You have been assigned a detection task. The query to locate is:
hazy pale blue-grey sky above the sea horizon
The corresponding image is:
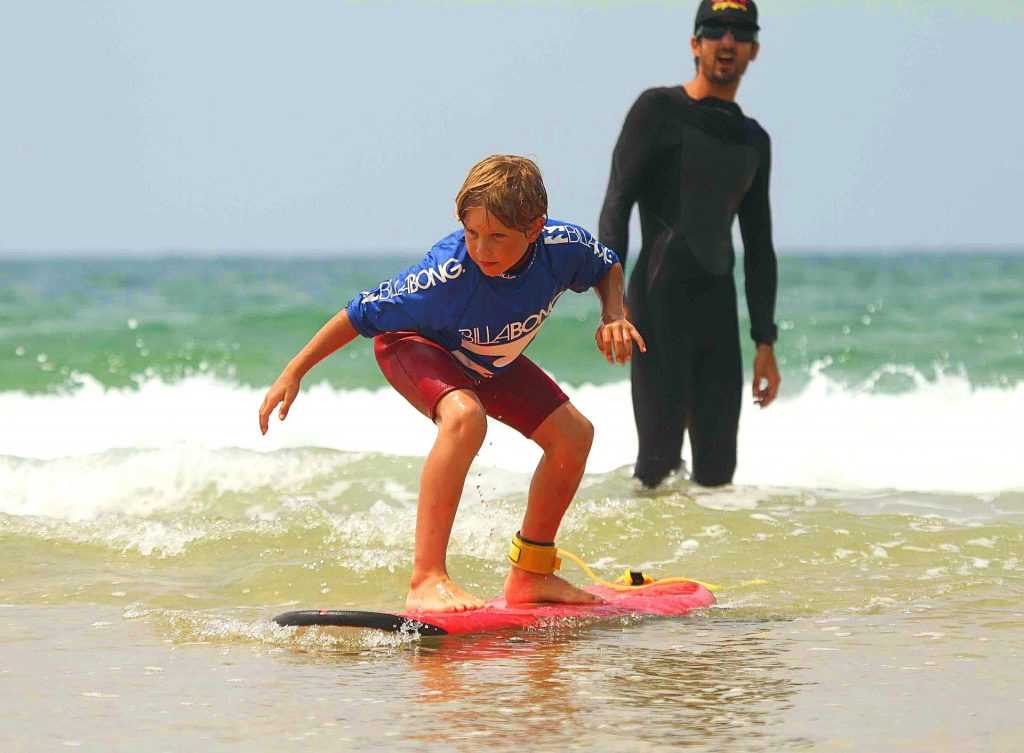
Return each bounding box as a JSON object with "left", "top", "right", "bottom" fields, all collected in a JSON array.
[{"left": 0, "top": 0, "right": 1024, "bottom": 251}]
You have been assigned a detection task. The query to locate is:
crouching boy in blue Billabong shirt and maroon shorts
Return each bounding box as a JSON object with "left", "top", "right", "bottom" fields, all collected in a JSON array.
[{"left": 259, "top": 155, "right": 645, "bottom": 612}]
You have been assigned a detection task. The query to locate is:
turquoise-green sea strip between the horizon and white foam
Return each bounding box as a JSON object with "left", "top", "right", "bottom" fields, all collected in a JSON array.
[{"left": 0, "top": 254, "right": 1024, "bottom": 392}]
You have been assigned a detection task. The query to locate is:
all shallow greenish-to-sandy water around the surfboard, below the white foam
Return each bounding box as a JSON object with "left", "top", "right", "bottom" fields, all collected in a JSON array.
[{"left": 0, "top": 473, "right": 1024, "bottom": 751}]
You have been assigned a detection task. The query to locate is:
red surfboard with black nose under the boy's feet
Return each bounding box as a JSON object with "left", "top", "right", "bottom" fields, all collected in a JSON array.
[{"left": 273, "top": 581, "right": 715, "bottom": 635}]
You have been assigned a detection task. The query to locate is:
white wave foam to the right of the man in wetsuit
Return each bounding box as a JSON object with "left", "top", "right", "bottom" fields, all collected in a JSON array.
[{"left": 736, "top": 364, "right": 1024, "bottom": 494}]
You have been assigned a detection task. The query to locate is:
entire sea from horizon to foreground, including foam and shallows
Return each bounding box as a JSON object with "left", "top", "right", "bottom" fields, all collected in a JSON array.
[{"left": 0, "top": 253, "right": 1024, "bottom": 751}]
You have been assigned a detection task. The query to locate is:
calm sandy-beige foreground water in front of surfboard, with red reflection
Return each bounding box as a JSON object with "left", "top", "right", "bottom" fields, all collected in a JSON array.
[{"left": 0, "top": 589, "right": 1024, "bottom": 751}]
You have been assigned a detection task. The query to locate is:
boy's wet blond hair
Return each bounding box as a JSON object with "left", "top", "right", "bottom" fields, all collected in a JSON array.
[{"left": 455, "top": 155, "right": 548, "bottom": 233}]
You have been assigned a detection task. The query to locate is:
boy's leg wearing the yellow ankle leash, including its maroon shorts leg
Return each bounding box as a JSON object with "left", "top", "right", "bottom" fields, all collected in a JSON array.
[{"left": 477, "top": 355, "right": 602, "bottom": 603}]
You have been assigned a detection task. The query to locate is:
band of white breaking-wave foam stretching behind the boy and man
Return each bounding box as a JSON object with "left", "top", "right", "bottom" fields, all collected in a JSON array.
[{"left": 0, "top": 374, "right": 1024, "bottom": 517}]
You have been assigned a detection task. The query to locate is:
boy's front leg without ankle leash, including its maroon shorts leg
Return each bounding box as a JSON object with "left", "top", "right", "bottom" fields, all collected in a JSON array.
[{"left": 374, "top": 333, "right": 486, "bottom": 612}]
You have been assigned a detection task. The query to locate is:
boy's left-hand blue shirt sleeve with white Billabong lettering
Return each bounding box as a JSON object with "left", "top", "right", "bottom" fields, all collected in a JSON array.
[{"left": 345, "top": 254, "right": 465, "bottom": 337}]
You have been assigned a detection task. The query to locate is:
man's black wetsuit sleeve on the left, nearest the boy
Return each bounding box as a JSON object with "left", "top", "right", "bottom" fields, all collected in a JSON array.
[{"left": 597, "top": 89, "right": 664, "bottom": 269}]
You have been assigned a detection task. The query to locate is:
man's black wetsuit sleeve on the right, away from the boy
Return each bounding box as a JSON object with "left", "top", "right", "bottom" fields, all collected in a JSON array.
[{"left": 738, "top": 128, "right": 778, "bottom": 345}]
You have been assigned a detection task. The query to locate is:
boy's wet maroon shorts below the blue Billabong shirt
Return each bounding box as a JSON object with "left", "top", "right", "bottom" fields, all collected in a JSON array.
[{"left": 374, "top": 332, "right": 568, "bottom": 437}]
